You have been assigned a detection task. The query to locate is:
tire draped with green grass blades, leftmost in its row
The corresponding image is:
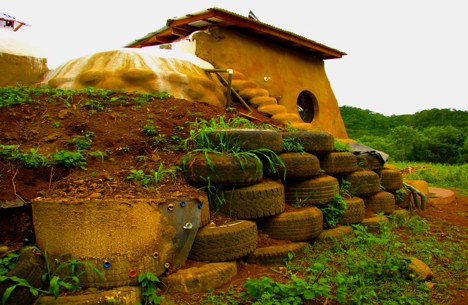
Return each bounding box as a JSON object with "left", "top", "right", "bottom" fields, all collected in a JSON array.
[{"left": 182, "top": 153, "right": 263, "bottom": 186}]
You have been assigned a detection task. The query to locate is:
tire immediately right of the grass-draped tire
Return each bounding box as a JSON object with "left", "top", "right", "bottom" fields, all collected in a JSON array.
[{"left": 264, "top": 152, "right": 320, "bottom": 182}]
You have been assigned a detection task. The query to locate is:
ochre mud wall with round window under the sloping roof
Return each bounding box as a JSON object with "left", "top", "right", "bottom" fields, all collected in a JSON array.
[{"left": 193, "top": 27, "right": 348, "bottom": 138}]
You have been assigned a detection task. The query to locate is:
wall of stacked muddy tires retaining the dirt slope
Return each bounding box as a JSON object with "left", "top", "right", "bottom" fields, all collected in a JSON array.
[{"left": 180, "top": 129, "right": 402, "bottom": 263}]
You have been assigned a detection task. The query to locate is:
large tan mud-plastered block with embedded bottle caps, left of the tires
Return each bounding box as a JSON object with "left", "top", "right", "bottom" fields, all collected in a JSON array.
[{"left": 32, "top": 198, "right": 177, "bottom": 288}]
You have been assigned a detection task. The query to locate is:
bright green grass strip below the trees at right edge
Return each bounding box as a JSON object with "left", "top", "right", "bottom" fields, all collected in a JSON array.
[{"left": 391, "top": 161, "right": 468, "bottom": 195}]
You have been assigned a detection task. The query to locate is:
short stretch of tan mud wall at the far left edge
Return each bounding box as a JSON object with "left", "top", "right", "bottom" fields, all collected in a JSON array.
[{"left": 0, "top": 53, "right": 48, "bottom": 87}]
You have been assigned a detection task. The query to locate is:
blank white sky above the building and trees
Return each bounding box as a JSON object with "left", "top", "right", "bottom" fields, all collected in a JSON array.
[{"left": 0, "top": 0, "right": 468, "bottom": 115}]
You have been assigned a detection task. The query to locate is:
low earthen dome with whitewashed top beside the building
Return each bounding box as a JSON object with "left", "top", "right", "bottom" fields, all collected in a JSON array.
[{"left": 42, "top": 49, "right": 226, "bottom": 106}]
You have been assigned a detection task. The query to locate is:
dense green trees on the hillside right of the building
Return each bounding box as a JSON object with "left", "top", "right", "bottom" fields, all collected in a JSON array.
[{"left": 340, "top": 106, "right": 468, "bottom": 164}]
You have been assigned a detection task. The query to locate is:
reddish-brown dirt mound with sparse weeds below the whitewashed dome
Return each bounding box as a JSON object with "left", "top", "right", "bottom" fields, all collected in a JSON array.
[{"left": 0, "top": 92, "right": 280, "bottom": 247}]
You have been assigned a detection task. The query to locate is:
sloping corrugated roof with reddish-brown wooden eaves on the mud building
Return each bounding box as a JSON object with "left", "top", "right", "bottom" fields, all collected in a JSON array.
[{"left": 125, "top": 8, "right": 346, "bottom": 59}]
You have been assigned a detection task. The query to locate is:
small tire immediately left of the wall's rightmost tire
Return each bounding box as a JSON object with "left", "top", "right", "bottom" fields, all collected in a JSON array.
[{"left": 343, "top": 170, "right": 380, "bottom": 197}]
